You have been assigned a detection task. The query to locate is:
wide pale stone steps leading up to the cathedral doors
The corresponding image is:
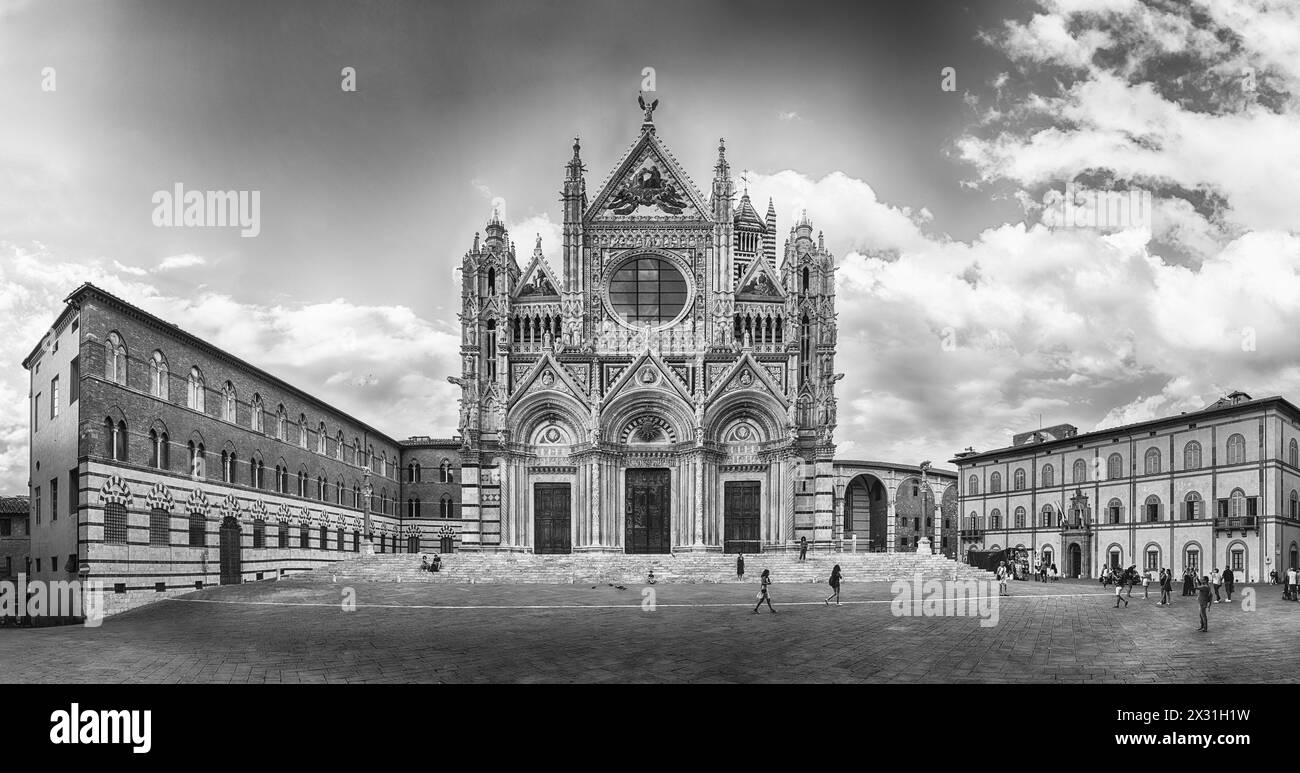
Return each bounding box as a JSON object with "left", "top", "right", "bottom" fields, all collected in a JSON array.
[{"left": 306, "top": 552, "right": 993, "bottom": 585}]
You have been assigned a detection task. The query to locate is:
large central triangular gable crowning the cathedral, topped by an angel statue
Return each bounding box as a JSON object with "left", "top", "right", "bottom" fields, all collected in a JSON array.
[{"left": 584, "top": 131, "right": 712, "bottom": 220}]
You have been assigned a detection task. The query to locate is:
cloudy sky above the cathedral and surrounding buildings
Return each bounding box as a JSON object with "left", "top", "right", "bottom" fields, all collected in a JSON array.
[{"left": 0, "top": 0, "right": 1300, "bottom": 492}]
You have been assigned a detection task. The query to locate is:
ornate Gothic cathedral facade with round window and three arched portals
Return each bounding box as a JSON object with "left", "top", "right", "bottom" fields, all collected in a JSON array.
[{"left": 451, "top": 105, "right": 839, "bottom": 553}]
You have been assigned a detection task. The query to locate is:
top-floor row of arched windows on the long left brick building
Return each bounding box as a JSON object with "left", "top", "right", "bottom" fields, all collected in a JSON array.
[{"left": 104, "top": 330, "right": 397, "bottom": 478}]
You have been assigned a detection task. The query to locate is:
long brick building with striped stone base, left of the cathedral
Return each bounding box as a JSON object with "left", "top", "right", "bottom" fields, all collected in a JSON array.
[{"left": 23, "top": 285, "right": 460, "bottom": 612}]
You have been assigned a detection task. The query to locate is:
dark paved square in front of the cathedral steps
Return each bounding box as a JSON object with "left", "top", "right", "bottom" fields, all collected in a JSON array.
[{"left": 0, "top": 576, "right": 1300, "bottom": 683}]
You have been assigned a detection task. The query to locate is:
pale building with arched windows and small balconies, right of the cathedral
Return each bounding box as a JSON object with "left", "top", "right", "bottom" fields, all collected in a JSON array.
[{"left": 953, "top": 392, "right": 1300, "bottom": 582}]
